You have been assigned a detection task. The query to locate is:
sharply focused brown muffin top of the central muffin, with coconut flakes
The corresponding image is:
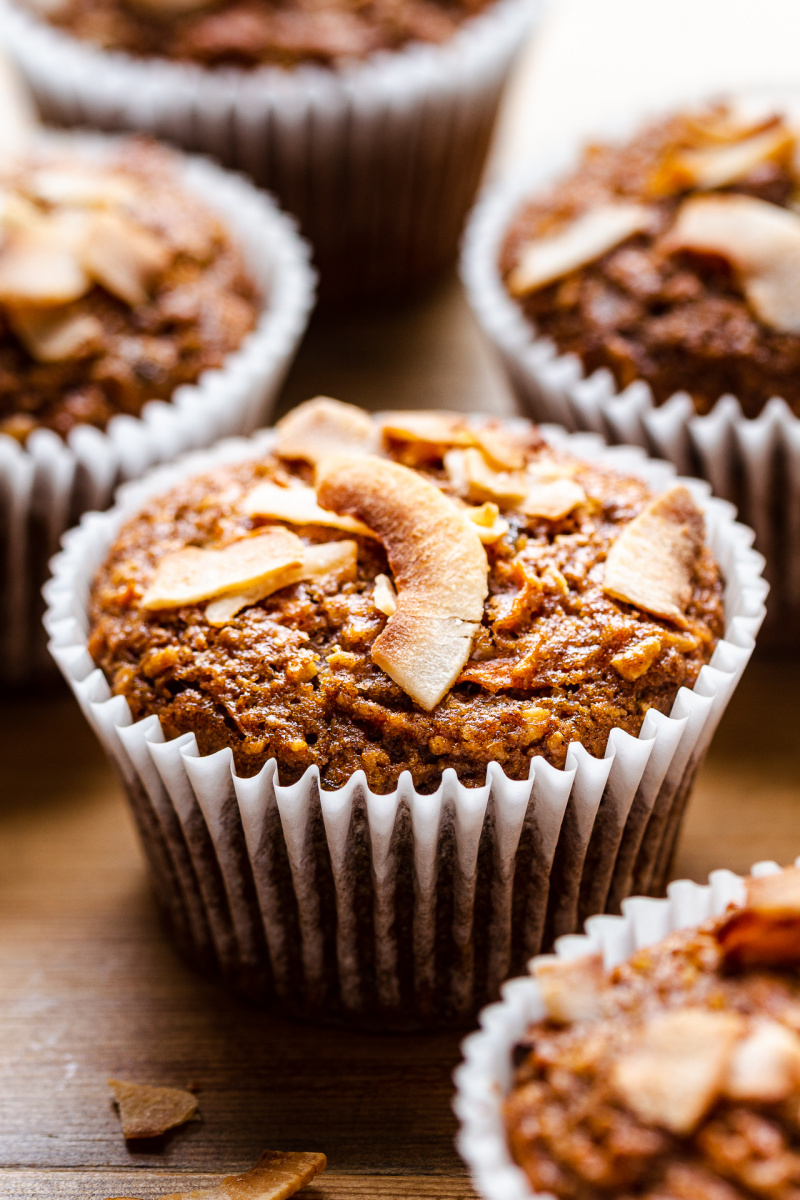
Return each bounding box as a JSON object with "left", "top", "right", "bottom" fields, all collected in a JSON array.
[{"left": 90, "top": 398, "right": 723, "bottom": 792}]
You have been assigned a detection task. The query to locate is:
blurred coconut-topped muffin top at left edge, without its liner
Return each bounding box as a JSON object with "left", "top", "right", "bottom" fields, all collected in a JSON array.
[{"left": 0, "top": 140, "right": 259, "bottom": 442}]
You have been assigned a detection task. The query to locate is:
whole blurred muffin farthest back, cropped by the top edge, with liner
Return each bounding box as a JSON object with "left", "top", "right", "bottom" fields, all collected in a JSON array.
[{"left": 0, "top": 0, "right": 540, "bottom": 301}]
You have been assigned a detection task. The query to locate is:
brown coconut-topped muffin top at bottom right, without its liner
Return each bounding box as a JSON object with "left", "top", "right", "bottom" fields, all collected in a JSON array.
[{"left": 505, "top": 869, "right": 800, "bottom": 1200}]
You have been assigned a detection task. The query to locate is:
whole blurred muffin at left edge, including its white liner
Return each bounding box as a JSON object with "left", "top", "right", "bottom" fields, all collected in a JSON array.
[{"left": 0, "top": 129, "right": 312, "bottom": 680}]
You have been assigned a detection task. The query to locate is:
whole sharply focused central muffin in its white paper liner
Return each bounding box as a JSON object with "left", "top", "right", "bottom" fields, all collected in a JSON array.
[{"left": 47, "top": 397, "right": 763, "bottom": 1026}]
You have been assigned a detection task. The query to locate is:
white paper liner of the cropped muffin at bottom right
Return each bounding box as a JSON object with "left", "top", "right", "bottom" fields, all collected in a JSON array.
[{"left": 453, "top": 858, "right": 800, "bottom": 1200}]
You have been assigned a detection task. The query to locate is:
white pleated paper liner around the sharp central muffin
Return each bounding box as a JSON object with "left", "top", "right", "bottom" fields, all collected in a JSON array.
[{"left": 46, "top": 422, "right": 766, "bottom": 1027}]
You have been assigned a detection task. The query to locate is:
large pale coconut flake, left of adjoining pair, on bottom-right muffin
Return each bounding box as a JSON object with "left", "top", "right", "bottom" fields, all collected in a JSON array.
[{"left": 612, "top": 1008, "right": 744, "bottom": 1136}]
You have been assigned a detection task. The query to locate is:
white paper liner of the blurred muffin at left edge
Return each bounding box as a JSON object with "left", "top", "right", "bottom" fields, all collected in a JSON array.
[{"left": 0, "top": 127, "right": 314, "bottom": 683}]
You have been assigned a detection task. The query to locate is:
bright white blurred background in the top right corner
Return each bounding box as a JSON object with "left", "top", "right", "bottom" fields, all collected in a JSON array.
[{"left": 493, "top": 0, "right": 800, "bottom": 172}]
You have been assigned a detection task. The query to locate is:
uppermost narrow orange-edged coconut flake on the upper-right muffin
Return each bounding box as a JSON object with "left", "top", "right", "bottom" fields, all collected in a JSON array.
[{"left": 660, "top": 126, "right": 796, "bottom": 192}]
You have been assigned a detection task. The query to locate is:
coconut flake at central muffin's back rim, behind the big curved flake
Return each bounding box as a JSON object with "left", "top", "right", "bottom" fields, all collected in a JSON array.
[{"left": 276, "top": 396, "right": 378, "bottom": 463}]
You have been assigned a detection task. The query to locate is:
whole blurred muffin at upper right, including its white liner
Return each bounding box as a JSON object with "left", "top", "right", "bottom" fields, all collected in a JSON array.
[{"left": 465, "top": 98, "right": 800, "bottom": 648}]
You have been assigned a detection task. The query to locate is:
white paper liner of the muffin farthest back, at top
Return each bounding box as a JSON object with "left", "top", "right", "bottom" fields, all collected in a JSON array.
[{"left": 0, "top": 0, "right": 543, "bottom": 298}]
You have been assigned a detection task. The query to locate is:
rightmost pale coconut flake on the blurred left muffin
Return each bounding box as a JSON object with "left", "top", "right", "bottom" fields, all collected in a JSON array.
[{"left": 83, "top": 212, "right": 173, "bottom": 308}]
